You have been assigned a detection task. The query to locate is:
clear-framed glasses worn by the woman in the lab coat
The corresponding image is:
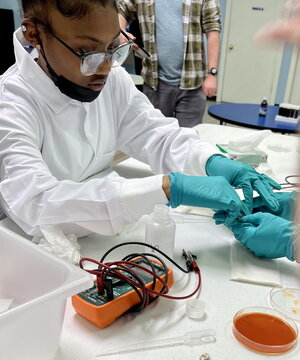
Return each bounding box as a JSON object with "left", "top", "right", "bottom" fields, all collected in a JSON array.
[{"left": 39, "top": 21, "right": 134, "bottom": 76}]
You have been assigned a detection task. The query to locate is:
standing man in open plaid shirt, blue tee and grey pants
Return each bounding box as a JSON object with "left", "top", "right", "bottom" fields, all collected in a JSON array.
[{"left": 118, "top": 0, "right": 221, "bottom": 127}]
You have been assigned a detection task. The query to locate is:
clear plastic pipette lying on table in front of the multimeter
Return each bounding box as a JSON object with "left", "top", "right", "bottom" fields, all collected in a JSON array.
[{"left": 96, "top": 329, "right": 216, "bottom": 357}]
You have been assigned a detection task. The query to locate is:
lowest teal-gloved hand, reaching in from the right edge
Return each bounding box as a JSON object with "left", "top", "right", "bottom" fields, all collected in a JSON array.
[{"left": 229, "top": 212, "right": 295, "bottom": 260}]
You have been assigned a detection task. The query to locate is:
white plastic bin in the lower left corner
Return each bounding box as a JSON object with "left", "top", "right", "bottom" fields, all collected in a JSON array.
[{"left": 0, "top": 227, "right": 93, "bottom": 360}]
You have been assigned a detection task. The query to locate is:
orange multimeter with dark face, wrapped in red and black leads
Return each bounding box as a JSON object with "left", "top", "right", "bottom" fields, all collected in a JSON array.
[{"left": 72, "top": 258, "right": 174, "bottom": 328}]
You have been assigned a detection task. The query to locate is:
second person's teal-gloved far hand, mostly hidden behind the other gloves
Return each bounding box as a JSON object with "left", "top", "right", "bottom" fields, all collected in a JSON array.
[{"left": 253, "top": 191, "right": 296, "bottom": 220}]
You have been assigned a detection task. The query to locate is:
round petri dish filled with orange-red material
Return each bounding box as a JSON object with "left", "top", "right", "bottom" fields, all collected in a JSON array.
[{"left": 232, "top": 307, "right": 298, "bottom": 354}]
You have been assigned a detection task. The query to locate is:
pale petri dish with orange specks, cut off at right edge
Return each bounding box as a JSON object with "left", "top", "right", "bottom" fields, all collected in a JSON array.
[{"left": 270, "top": 288, "right": 300, "bottom": 320}]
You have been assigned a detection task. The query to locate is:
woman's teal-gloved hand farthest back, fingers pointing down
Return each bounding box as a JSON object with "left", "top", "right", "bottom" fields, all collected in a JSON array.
[{"left": 206, "top": 155, "right": 281, "bottom": 213}]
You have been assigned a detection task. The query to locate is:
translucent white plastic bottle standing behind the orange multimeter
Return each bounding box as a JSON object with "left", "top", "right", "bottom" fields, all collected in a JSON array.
[{"left": 145, "top": 204, "right": 176, "bottom": 265}]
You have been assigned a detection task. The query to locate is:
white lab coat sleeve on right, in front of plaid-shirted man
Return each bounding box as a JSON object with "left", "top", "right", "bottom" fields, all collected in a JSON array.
[{"left": 112, "top": 69, "right": 220, "bottom": 175}]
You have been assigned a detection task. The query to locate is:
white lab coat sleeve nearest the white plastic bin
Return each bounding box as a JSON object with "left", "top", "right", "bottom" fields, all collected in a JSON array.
[{"left": 0, "top": 101, "right": 167, "bottom": 235}]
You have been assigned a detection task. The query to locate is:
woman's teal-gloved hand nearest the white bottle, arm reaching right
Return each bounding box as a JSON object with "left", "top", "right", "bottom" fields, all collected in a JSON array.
[{"left": 169, "top": 173, "right": 249, "bottom": 224}]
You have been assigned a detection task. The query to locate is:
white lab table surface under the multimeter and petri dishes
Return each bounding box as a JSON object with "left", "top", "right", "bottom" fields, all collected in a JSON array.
[{"left": 54, "top": 125, "right": 300, "bottom": 360}]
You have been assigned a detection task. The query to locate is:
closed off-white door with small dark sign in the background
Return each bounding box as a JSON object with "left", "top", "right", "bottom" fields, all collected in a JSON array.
[{"left": 217, "top": 0, "right": 285, "bottom": 104}]
